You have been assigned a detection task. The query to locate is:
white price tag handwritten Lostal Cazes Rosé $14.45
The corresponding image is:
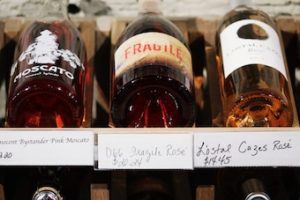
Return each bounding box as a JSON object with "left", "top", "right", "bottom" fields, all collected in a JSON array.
[{"left": 194, "top": 131, "right": 300, "bottom": 167}]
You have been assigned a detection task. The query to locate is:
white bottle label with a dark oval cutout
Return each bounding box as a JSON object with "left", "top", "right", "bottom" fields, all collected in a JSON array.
[{"left": 220, "top": 19, "right": 287, "bottom": 78}]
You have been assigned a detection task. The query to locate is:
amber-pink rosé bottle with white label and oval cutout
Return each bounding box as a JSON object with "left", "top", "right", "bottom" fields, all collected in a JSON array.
[{"left": 216, "top": 5, "right": 295, "bottom": 127}]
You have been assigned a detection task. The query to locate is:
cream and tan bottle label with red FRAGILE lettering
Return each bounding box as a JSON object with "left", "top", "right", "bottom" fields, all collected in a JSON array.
[{"left": 115, "top": 32, "right": 193, "bottom": 80}]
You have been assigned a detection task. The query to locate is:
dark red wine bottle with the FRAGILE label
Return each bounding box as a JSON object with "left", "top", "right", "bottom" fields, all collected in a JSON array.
[{"left": 111, "top": 0, "right": 195, "bottom": 127}]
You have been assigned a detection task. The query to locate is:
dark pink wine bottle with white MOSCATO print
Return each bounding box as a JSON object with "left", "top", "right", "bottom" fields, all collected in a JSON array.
[{"left": 6, "top": 0, "right": 86, "bottom": 127}]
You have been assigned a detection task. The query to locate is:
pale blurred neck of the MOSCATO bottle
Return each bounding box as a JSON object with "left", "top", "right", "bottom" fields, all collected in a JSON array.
[{"left": 39, "top": 0, "right": 69, "bottom": 21}]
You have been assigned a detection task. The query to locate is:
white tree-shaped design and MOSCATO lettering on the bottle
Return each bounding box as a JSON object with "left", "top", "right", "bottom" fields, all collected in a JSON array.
[{"left": 10, "top": 30, "right": 84, "bottom": 83}]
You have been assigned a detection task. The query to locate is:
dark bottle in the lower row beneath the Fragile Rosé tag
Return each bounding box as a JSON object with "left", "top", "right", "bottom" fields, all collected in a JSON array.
[{"left": 127, "top": 172, "right": 174, "bottom": 200}]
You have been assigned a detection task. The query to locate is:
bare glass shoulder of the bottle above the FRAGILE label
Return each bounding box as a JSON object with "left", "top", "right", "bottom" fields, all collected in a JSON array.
[{"left": 116, "top": 14, "right": 187, "bottom": 47}]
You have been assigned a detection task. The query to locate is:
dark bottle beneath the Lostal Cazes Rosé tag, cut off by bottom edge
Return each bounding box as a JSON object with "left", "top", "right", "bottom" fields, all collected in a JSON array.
[{"left": 216, "top": 168, "right": 288, "bottom": 200}]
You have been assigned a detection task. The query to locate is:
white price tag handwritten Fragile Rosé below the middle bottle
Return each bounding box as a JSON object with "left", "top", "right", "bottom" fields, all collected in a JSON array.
[{"left": 98, "top": 133, "right": 193, "bottom": 169}]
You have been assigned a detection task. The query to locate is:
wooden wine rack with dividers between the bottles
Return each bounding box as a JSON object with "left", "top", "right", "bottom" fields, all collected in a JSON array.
[{"left": 0, "top": 16, "right": 300, "bottom": 200}]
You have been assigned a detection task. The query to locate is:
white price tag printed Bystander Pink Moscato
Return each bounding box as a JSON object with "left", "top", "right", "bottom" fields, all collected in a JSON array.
[{"left": 0, "top": 131, "right": 94, "bottom": 166}]
